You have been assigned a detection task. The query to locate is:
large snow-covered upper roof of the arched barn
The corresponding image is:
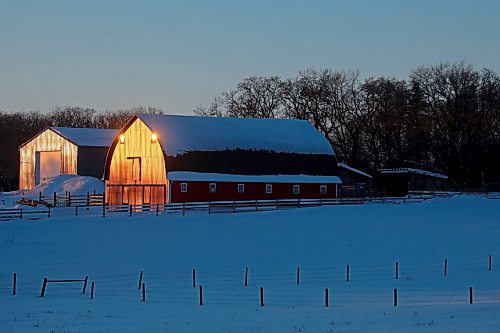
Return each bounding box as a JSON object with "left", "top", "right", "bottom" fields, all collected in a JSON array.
[{"left": 137, "top": 114, "right": 334, "bottom": 156}]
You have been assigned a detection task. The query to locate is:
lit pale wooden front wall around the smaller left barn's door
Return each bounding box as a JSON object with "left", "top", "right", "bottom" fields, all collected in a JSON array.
[{"left": 19, "top": 130, "right": 78, "bottom": 189}]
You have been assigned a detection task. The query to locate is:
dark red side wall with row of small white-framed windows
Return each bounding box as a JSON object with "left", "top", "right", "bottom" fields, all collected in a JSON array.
[{"left": 170, "top": 181, "right": 336, "bottom": 202}]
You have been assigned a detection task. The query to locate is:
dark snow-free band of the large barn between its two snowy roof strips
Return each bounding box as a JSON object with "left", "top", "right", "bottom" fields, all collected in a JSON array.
[{"left": 165, "top": 149, "right": 338, "bottom": 176}]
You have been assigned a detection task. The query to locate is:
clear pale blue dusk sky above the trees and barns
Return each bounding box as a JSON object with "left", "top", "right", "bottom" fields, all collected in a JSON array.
[{"left": 0, "top": 0, "right": 500, "bottom": 114}]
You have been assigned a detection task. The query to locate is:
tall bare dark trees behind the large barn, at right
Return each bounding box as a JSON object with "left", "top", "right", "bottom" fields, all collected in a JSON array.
[{"left": 194, "top": 62, "right": 500, "bottom": 188}]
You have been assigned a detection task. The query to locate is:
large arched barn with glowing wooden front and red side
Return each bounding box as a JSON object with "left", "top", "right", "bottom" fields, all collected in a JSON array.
[{"left": 105, "top": 114, "right": 341, "bottom": 204}]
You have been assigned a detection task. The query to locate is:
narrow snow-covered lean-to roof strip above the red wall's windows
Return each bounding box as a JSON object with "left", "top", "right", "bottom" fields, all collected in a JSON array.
[{"left": 167, "top": 171, "right": 342, "bottom": 184}]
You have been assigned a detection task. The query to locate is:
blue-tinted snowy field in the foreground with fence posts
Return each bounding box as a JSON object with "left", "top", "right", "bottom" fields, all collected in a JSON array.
[{"left": 0, "top": 196, "right": 500, "bottom": 332}]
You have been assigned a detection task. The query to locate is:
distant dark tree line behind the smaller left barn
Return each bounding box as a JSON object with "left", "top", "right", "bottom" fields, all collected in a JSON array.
[{"left": 0, "top": 106, "right": 164, "bottom": 191}]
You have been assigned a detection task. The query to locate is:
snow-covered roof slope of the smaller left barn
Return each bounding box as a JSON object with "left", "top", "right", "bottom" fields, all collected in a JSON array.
[{"left": 49, "top": 127, "right": 118, "bottom": 147}]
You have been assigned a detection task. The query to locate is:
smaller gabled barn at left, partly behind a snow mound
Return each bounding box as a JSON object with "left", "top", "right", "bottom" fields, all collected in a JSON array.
[{"left": 19, "top": 127, "right": 118, "bottom": 190}]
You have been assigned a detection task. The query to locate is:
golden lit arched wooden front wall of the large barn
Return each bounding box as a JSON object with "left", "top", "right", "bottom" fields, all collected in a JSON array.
[{"left": 106, "top": 119, "right": 168, "bottom": 205}]
